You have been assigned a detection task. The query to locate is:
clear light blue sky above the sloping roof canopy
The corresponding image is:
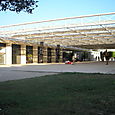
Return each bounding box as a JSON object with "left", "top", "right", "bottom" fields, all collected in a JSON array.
[{"left": 0, "top": 0, "right": 115, "bottom": 26}]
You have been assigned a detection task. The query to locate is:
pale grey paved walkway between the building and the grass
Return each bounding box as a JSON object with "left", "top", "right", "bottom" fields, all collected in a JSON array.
[{"left": 0, "top": 62, "right": 115, "bottom": 81}]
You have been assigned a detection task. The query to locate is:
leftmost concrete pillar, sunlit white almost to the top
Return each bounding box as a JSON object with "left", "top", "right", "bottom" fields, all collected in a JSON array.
[{"left": 5, "top": 43, "right": 12, "bottom": 65}]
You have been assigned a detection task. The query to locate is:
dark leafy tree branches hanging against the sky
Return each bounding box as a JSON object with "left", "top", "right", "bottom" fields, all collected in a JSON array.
[{"left": 0, "top": 0, "right": 38, "bottom": 13}]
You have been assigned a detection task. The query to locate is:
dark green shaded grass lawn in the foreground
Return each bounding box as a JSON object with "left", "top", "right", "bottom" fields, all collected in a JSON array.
[{"left": 0, "top": 73, "right": 115, "bottom": 115}]
